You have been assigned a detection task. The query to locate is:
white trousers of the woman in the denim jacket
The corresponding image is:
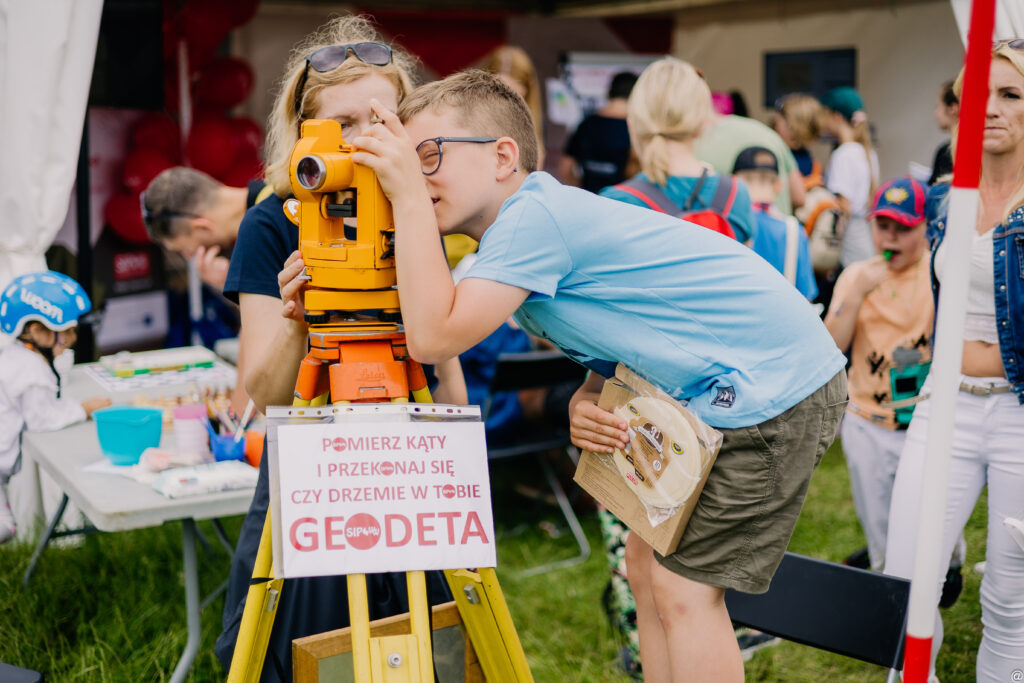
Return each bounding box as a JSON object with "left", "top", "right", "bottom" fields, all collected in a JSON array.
[{"left": 886, "top": 378, "right": 1024, "bottom": 683}]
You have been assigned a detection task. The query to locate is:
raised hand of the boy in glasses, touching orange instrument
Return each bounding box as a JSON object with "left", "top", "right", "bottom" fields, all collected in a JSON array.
[{"left": 352, "top": 99, "right": 430, "bottom": 204}]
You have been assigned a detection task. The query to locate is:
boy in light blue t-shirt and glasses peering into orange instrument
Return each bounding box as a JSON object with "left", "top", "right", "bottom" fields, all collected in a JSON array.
[{"left": 319, "top": 72, "right": 846, "bottom": 681}]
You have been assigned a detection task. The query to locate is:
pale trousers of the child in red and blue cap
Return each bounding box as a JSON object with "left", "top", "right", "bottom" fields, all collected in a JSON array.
[{"left": 840, "top": 411, "right": 906, "bottom": 571}]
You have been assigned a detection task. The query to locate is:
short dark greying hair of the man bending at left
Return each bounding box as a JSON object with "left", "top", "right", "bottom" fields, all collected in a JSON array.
[{"left": 139, "top": 166, "right": 223, "bottom": 242}]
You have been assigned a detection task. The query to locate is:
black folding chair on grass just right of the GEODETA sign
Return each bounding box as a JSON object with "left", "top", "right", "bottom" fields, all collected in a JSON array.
[{"left": 483, "top": 351, "right": 590, "bottom": 575}]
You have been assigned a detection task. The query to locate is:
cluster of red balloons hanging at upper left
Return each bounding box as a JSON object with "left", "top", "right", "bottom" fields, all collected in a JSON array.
[{"left": 103, "top": 0, "right": 263, "bottom": 243}]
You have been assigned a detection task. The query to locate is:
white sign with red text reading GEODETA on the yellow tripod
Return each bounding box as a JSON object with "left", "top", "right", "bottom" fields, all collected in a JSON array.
[{"left": 270, "top": 422, "right": 497, "bottom": 579}]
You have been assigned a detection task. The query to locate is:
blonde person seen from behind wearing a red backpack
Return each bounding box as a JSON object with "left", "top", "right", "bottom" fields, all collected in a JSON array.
[{"left": 601, "top": 57, "right": 757, "bottom": 243}]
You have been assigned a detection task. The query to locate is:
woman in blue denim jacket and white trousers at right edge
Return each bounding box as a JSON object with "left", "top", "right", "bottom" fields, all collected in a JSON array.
[{"left": 886, "top": 40, "right": 1024, "bottom": 682}]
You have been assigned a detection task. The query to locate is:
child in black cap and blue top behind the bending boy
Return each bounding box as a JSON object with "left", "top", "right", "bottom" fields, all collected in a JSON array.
[{"left": 732, "top": 146, "right": 818, "bottom": 301}]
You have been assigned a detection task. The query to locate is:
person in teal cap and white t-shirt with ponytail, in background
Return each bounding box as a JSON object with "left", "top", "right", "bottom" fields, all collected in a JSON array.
[{"left": 821, "top": 86, "right": 879, "bottom": 267}]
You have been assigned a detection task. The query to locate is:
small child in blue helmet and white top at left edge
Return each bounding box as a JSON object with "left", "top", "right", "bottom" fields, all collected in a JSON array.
[{"left": 0, "top": 271, "right": 111, "bottom": 544}]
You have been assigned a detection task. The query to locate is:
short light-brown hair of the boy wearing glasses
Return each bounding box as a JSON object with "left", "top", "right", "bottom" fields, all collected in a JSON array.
[{"left": 398, "top": 69, "right": 538, "bottom": 173}]
